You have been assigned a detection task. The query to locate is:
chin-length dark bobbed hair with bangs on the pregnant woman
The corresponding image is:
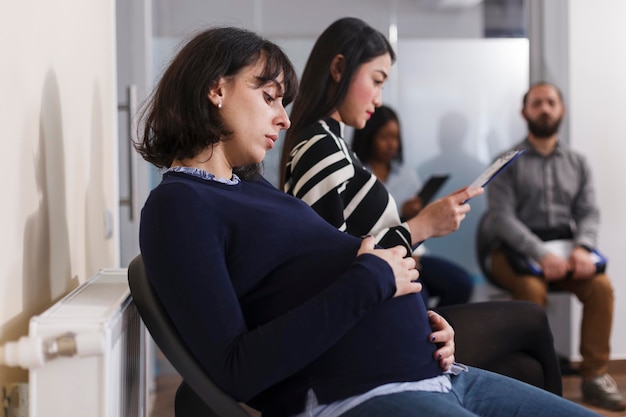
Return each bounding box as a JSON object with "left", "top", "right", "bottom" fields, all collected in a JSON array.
[{"left": 135, "top": 27, "right": 298, "bottom": 178}]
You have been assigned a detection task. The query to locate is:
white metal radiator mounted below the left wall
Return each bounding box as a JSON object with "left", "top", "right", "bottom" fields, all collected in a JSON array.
[{"left": 29, "top": 269, "right": 148, "bottom": 417}]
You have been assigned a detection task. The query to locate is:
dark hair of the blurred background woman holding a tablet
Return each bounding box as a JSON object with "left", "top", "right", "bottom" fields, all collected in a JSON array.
[{"left": 352, "top": 106, "right": 403, "bottom": 164}]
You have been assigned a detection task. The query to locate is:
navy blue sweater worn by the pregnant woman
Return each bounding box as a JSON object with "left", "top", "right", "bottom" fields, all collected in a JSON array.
[{"left": 140, "top": 172, "right": 442, "bottom": 416}]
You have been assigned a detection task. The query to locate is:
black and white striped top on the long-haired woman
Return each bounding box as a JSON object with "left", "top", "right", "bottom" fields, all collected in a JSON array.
[{"left": 284, "top": 118, "right": 411, "bottom": 253}]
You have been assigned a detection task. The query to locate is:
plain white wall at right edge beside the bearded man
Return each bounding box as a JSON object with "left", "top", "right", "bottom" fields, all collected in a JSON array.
[{"left": 568, "top": 0, "right": 626, "bottom": 359}]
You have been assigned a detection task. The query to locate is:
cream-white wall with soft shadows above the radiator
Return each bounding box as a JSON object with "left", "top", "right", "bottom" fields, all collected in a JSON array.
[{"left": 0, "top": 0, "right": 118, "bottom": 385}]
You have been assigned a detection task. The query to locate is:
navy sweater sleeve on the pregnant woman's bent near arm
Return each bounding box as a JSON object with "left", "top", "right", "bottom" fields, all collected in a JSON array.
[{"left": 140, "top": 184, "right": 395, "bottom": 401}]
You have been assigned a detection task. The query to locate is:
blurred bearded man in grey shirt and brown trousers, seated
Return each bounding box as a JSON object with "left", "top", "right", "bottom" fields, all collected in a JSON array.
[{"left": 479, "top": 82, "right": 626, "bottom": 411}]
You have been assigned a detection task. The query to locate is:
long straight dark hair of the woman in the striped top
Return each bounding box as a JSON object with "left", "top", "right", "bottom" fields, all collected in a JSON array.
[{"left": 280, "top": 17, "right": 396, "bottom": 188}]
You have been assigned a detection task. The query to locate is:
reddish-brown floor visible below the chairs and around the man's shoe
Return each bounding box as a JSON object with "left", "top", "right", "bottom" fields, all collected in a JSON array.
[{"left": 150, "top": 354, "right": 626, "bottom": 417}]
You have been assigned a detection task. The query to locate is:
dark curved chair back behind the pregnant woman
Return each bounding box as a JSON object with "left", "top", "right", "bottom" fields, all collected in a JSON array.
[{"left": 128, "top": 255, "right": 250, "bottom": 417}]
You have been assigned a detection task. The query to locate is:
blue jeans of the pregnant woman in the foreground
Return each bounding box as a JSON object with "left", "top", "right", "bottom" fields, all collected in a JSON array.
[{"left": 334, "top": 368, "right": 599, "bottom": 417}]
